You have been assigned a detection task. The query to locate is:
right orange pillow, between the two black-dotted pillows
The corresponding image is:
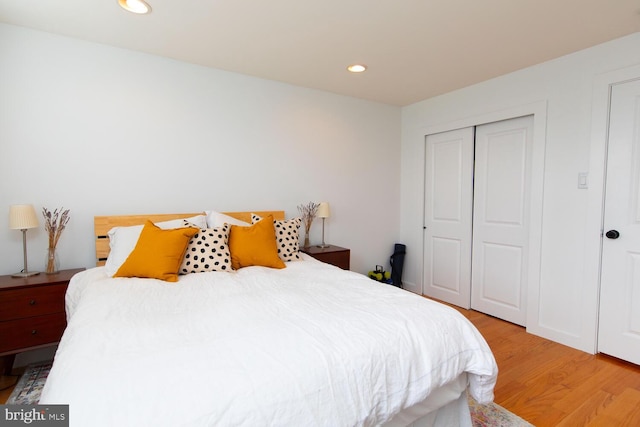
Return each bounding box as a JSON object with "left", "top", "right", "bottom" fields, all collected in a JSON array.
[{"left": 229, "top": 215, "right": 285, "bottom": 270}]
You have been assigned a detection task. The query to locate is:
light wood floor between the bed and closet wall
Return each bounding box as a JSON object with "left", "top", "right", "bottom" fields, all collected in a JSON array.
[{"left": 454, "top": 307, "right": 640, "bottom": 427}]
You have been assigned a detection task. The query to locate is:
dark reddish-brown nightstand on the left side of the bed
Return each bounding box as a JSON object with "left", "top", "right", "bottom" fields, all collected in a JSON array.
[{"left": 0, "top": 268, "right": 84, "bottom": 373}]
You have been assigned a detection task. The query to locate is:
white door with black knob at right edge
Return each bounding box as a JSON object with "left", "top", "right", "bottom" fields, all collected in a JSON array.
[{"left": 598, "top": 80, "right": 640, "bottom": 364}]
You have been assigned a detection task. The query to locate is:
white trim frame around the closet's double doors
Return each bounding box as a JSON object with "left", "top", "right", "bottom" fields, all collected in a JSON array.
[{"left": 421, "top": 100, "right": 547, "bottom": 335}]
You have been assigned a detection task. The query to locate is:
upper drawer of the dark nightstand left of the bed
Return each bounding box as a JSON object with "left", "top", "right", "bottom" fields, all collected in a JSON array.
[{"left": 0, "top": 283, "right": 67, "bottom": 322}]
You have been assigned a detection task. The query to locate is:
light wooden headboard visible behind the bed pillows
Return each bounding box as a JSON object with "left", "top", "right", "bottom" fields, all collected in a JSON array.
[{"left": 93, "top": 211, "right": 284, "bottom": 266}]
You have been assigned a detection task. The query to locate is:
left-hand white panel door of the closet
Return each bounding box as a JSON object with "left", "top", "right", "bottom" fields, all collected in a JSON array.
[{"left": 423, "top": 127, "right": 474, "bottom": 308}]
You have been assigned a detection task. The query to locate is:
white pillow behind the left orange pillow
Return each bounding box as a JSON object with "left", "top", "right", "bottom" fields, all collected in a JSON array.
[{"left": 104, "top": 215, "right": 207, "bottom": 277}]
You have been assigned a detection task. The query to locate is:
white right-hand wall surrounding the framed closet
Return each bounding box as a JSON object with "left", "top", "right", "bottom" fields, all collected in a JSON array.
[{"left": 401, "top": 33, "right": 640, "bottom": 352}]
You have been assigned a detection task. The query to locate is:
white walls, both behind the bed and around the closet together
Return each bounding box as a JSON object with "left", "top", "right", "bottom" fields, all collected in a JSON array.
[{"left": 6, "top": 24, "right": 640, "bottom": 360}]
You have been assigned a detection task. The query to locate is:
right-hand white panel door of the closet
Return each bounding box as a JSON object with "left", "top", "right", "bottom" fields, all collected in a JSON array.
[{"left": 471, "top": 116, "right": 533, "bottom": 326}]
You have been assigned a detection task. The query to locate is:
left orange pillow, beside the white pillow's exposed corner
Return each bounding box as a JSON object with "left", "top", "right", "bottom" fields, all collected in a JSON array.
[{"left": 113, "top": 221, "right": 199, "bottom": 282}]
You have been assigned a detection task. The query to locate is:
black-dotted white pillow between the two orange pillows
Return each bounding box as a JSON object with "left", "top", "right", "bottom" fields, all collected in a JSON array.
[{"left": 179, "top": 221, "right": 233, "bottom": 274}]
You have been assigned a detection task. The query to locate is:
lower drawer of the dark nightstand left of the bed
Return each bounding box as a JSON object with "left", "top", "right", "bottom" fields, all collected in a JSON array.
[{"left": 0, "top": 312, "right": 67, "bottom": 353}]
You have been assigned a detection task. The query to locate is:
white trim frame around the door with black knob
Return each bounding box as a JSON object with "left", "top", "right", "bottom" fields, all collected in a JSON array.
[{"left": 581, "top": 65, "right": 640, "bottom": 354}]
